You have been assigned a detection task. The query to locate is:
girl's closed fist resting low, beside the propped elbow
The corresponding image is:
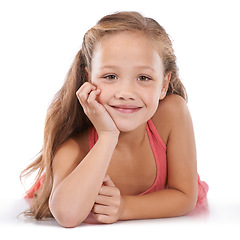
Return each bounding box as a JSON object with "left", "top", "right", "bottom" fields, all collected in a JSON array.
[{"left": 92, "top": 175, "right": 124, "bottom": 223}]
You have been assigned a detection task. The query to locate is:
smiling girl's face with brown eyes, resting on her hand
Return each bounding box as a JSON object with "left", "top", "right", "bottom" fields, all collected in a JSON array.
[{"left": 90, "top": 32, "right": 168, "bottom": 132}]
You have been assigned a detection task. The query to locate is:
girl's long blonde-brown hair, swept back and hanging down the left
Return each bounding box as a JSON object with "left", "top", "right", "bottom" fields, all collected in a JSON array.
[{"left": 21, "top": 12, "right": 187, "bottom": 220}]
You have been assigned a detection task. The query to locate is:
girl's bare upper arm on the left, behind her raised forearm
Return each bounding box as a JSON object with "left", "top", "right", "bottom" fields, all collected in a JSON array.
[{"left": 52, "top": 131, "right": 89, "bottom": 188}]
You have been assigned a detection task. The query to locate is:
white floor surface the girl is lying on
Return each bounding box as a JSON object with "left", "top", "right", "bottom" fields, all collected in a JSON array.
[{"left": 0, "top": 198, "right": 240, "bottom": 240}]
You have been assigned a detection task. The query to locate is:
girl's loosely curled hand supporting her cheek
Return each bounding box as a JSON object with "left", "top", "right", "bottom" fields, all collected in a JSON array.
[{"left": 76, "top": 82, "right": 119, "bottom": 137}]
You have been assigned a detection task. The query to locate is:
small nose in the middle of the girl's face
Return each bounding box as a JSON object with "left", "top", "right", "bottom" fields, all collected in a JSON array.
[{"left": 115, "top": 81, "right": 136, "bottom": 101}]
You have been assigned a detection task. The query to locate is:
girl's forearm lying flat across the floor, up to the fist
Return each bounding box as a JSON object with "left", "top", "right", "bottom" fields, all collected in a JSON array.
[{"left": 120, "top": 189, "right": 196, "bottom": 220}]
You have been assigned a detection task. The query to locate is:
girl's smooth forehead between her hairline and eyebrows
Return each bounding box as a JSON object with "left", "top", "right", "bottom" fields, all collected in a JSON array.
[{"left": 92, "top": 31, "right": 162, "bottom": 71}]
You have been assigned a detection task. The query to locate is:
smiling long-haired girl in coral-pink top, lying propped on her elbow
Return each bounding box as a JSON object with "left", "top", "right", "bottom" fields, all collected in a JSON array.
[{"left": 20, "top": 12, "right": 208, "bottom": 227}]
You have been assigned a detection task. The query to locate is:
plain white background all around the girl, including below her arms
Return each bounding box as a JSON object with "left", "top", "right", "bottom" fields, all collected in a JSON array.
[{"left": 0, "top": 0, "right": 240, "bottom": 239}]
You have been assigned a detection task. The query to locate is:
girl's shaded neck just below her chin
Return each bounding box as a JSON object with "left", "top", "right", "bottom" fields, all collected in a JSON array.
[{"left": 116, "top": 123, "right": 147, "bottom": 150}]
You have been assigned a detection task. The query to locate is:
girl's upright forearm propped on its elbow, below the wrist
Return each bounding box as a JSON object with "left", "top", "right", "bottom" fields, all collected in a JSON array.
[{"left": 49, "top": 136, "right": 117, "bottom": 226}]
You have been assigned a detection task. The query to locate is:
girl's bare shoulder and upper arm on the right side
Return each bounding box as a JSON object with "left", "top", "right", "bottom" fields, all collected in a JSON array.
[{"left": 154, "top": 95, "right": 197, "bottom": 204}]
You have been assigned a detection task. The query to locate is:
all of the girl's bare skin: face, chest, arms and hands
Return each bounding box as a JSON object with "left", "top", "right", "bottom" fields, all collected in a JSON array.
[{"left": 49, "top": 32, "right": 197, "bottom": 227}]
